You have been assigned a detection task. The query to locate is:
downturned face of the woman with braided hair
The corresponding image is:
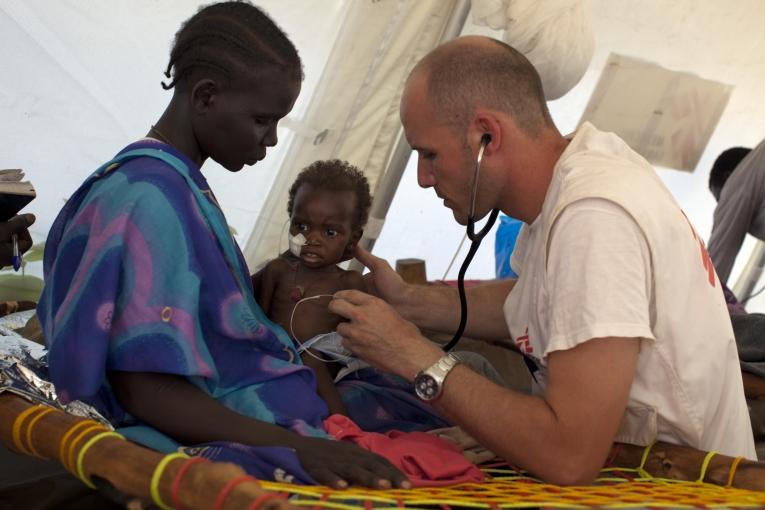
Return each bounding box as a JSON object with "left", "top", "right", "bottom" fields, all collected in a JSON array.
[{"left": 192, "top": 67, "right": 301, "bottom": 172}]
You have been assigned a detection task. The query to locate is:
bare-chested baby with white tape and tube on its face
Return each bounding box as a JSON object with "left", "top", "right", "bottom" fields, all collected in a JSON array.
[{"left": 252, "top": 160, "right": 372, "bottom": 414}]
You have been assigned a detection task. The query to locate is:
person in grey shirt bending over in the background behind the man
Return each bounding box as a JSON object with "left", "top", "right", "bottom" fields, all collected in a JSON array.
[{"left": 707, "top": 140, "right": 765, "bottom": 283}]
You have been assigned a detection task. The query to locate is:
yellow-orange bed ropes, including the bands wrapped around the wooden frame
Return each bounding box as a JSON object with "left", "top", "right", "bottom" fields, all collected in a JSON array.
[{"left": 5, "top": 406, "right": 765, "bottom": 510}]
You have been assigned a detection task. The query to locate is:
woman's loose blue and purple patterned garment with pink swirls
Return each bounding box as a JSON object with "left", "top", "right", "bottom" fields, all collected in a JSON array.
[{"left": 38, "top": 139, "right": 447, "bottom": 479}]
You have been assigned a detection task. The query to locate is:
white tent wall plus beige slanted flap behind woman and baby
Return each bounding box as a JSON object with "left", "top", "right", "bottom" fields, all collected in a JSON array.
[{"left": 0, "top": 0, "right": 592, "bottom": 282}]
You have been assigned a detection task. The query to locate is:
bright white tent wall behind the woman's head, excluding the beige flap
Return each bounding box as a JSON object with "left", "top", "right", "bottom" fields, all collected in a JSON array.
[{"left": 0, "top": 0, "right": 352, "bottom": 275}]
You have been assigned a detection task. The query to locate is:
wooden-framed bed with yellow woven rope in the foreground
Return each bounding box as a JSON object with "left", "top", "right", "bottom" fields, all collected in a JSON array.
[{"left": 0, "top": 393, "right": 765, "bottom": 510}]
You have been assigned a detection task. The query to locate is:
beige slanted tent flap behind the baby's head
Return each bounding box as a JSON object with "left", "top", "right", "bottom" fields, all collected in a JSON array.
[{"left": 244, "top": 0, "right": 455, "bottom": 268}]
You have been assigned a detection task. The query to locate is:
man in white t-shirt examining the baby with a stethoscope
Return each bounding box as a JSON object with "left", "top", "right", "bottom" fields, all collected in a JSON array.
[{"left": 330, "top": 37, "right": 756, "bottom": 484}]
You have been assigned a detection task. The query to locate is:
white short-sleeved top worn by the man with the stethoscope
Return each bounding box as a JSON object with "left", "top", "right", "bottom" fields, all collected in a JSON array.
[{"left": 505, "top": 124, "right": 756, "bottom": 459}]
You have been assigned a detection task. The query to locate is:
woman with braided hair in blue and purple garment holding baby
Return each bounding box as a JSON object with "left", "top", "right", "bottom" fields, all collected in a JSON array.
[{"left": 38, "top": 2, "right": 408, "bottom": 488}]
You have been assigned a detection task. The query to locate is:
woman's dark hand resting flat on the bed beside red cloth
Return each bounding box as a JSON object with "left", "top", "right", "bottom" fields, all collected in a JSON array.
[{"left": 295, "top": 437, "right": 411, "bottom": 489}]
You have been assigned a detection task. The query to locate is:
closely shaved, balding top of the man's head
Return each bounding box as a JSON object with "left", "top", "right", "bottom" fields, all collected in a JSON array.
[{"left": 407, "top": 36, "right": 552, "bottom": 136}]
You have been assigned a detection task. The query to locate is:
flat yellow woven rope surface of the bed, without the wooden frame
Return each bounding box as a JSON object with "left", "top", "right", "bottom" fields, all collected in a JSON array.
[{"left": 252, "top": 464, "right": 765, "bottom": 510}]
